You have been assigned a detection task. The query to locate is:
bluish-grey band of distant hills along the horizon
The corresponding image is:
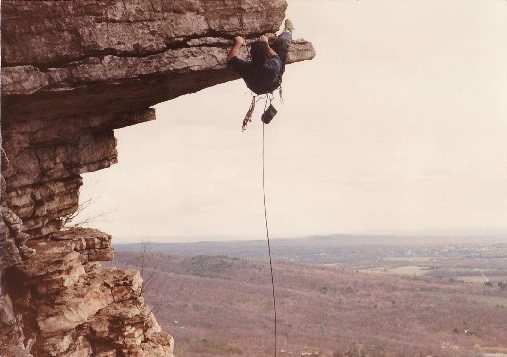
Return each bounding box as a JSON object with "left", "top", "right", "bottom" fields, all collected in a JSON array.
[{"left": 114, "top": 234, "right": 507, "bottom": 263}]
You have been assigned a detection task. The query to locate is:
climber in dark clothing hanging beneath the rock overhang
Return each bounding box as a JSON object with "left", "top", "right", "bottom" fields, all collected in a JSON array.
[{"left": 227, "top": 19, "right": 294, "bottom": 95}]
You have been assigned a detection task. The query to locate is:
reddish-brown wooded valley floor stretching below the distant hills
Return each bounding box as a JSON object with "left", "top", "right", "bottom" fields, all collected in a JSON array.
[{"left": 114, "top": 235, "right": 507, "bottom": 356}]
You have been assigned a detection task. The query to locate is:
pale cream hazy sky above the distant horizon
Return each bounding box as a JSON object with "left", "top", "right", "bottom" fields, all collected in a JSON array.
[{"left": 81, "top": 0, "right": 507, "bottom": 242}]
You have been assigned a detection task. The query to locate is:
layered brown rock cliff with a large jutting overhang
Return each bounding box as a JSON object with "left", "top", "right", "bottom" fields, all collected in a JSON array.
[{"left": 0, "top": 0, "right": 315, "bottom": 356}]
